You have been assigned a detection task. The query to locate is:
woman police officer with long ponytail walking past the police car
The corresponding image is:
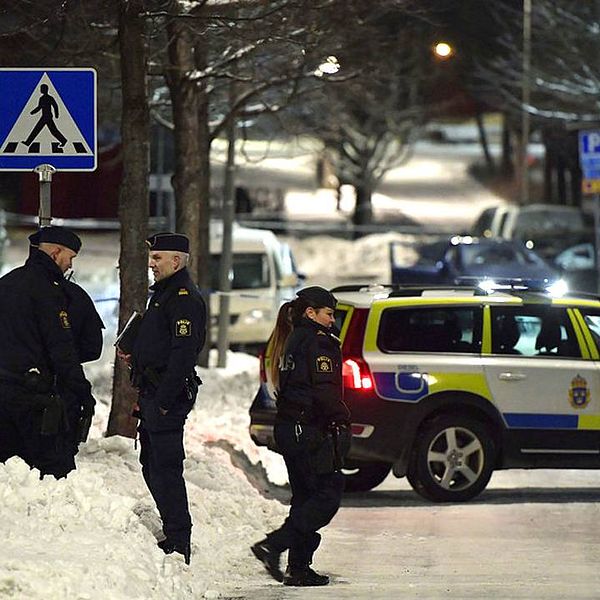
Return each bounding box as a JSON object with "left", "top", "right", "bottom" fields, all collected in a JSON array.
[{"left": 251, "top": 286, "right": 350, "bottom": 586}]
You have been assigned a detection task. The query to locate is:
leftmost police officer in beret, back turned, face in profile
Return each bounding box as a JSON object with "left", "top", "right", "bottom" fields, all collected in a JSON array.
[{"left": 0, "top": 226, "right": 95, "bottom": 479}]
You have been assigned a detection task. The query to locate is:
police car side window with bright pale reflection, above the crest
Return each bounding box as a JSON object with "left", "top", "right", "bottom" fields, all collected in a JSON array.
[{"left": 491, "top": 306, "right": 581, "bottom": 358}]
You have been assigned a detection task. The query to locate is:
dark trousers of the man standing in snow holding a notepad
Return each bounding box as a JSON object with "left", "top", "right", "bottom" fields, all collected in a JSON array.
[{"left": 138, "top": 396, "right": 193, "bottom": 544}]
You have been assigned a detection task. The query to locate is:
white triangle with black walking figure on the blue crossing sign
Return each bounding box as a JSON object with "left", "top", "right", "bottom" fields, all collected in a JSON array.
[{"left": 0, "top": 73, "right": 93, "bottom": 156}]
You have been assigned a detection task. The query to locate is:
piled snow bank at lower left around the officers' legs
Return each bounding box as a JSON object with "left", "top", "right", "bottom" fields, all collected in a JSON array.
[{"left": 0, "top": 353, "right": 286, "bottom": 600}]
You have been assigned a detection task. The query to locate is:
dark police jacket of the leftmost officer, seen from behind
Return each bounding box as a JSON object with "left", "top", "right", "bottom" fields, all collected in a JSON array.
[{"left": 0, "top": 249, "right": 94, "bottom": 403}]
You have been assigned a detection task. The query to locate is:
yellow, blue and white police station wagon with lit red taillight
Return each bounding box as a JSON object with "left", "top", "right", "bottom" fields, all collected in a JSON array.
[{"left": 250, "top": 282, "right": 600, "bottom": 502}]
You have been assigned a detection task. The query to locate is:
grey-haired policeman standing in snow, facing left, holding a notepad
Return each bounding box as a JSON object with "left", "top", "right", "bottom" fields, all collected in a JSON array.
[{"left": 121, "top": 232, "right": 206, "bottom": 564}]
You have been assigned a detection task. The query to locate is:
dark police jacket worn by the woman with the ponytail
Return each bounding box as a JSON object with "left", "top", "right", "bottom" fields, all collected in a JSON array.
[{"left": 277, "top": 317, "right": 350, "bottom": 427}]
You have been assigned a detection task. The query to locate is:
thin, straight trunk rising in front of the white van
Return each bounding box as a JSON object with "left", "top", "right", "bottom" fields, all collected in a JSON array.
[{"left": 195, "top": 28, "right": 211, "bottom": 367}]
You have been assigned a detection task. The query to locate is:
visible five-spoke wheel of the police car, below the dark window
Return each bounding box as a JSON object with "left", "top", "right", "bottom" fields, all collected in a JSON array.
[{"left": 408, "top": 415, "right": 494, "bottom": 502}]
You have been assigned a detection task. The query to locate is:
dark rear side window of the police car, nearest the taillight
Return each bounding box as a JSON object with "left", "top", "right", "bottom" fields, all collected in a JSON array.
[{"left": 377, "top": 306, "right": 481, "bottom": 353}]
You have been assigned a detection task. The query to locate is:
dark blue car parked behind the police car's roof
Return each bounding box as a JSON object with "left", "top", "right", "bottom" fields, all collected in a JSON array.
[{"left": 390, "top": 236, "right": 561, "bottom": 286}]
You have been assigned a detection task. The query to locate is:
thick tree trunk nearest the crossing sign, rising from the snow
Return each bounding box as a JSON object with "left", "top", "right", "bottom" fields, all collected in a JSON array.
[{"left": 106, "top": 0, "right": 150, "bottom": 437}]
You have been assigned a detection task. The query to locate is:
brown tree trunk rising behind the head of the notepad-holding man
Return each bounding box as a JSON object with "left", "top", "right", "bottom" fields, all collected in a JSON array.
[{"left": 166, "top": 7, "right": 206, "bottom": 274}]
